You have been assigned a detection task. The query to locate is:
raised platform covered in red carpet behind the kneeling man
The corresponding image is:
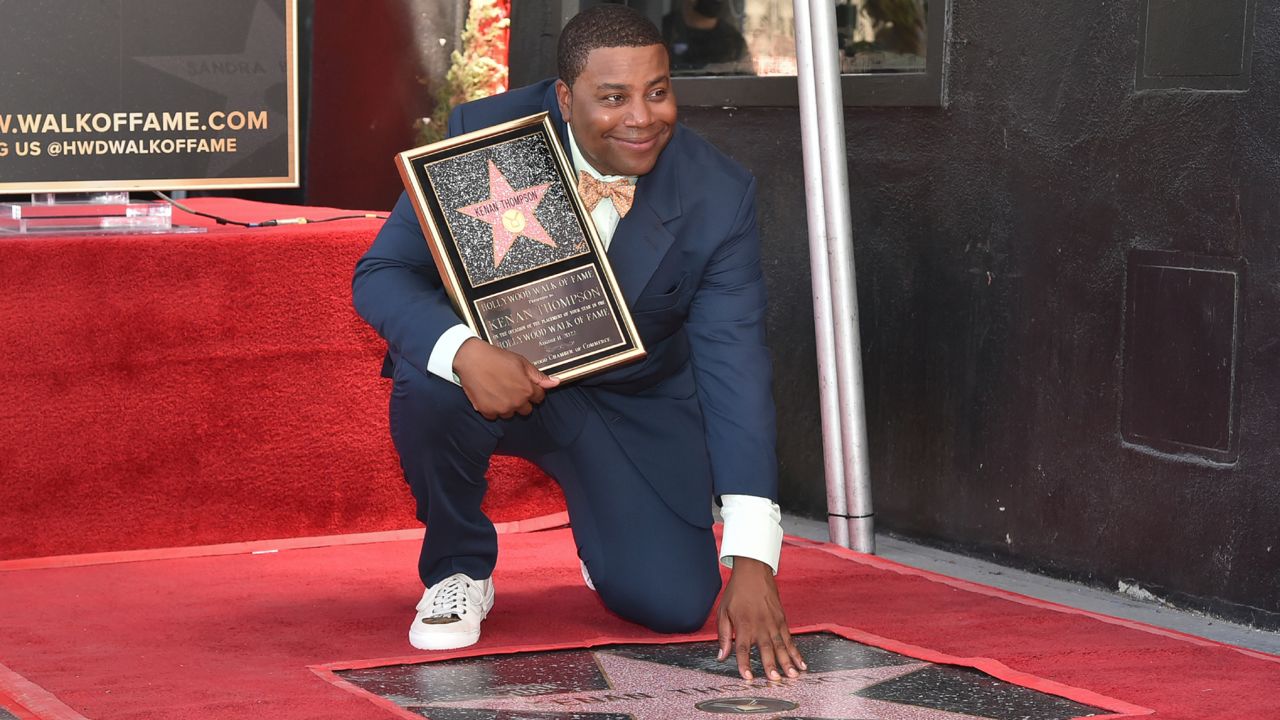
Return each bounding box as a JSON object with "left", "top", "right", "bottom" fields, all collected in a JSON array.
[{"left": 0, "top": 199, "right": 563, "bottom": 560}]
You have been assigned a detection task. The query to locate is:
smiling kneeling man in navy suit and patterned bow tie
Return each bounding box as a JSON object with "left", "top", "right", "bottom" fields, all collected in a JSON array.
[{"left": 353, "top": 5, "right": 804, "bottom": 679}]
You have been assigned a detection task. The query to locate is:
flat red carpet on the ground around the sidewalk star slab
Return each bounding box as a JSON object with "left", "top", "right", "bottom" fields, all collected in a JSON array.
[{"left": 0, "top": 530, "right": 1280, "bottom": 720}]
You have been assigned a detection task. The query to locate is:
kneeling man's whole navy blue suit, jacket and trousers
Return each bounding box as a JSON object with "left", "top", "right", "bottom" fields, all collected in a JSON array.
[{"left": 353, "top": 81, "right": 777, "bottom": 630}]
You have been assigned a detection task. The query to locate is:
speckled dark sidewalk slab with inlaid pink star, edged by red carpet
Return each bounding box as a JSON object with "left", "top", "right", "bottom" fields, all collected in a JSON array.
[{"left": 339, "top": 633, "right": 1123, "bottom": 720}]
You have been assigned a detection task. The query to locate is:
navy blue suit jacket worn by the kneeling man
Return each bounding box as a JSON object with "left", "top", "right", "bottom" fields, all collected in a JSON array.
[{"left": 352, "top": 79, "right": 777, "bottom": 527}]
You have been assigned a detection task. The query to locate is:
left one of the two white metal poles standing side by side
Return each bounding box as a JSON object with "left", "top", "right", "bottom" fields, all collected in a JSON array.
[{"left": 794, "top": 0, "right": 849, "bottom": 547}]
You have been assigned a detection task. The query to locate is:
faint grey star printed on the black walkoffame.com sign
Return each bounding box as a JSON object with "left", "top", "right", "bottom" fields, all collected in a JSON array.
[{"left": 134, "top": 0, "right": 288, "bottom": 177}]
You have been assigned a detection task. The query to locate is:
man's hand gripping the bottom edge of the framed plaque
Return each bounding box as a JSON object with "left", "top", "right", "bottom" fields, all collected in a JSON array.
[{"left": 453, "top": 337, "right": 559, "bottom": 420}]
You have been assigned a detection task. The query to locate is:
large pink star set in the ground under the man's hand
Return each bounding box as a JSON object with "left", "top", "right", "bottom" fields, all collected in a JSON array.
[{"left": 420, "top": 652, "right": 998, "bottom": 720}]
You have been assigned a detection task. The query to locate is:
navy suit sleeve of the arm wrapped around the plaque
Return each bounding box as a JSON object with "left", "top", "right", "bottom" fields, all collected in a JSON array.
[{"left": 351, "top": 106, "right": 465, "bottom": 374}]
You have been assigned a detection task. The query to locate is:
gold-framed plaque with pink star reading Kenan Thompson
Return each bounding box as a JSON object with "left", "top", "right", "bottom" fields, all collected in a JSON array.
[{"left": 396, "top": 113, "right": 645, "bottom": 380}]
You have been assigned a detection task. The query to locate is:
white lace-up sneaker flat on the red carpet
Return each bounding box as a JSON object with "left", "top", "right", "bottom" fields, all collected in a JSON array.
[{"left": 408, "top": 573, "right": 493, "bottom": 650}]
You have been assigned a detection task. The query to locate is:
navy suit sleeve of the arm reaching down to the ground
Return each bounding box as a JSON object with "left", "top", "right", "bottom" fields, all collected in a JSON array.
[{"left": 685, "top": 178, "right": 778, "bottom": 501}]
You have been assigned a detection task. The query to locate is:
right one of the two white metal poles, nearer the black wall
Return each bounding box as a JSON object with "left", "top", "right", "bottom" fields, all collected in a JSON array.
[{"left": 809, "top": 0, "right": 876, "bottom": 552}]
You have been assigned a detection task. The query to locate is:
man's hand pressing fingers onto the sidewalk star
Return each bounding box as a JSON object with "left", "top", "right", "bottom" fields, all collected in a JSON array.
[{"left": 717, "top": 557, "right": 809, "bottom": 680}]
